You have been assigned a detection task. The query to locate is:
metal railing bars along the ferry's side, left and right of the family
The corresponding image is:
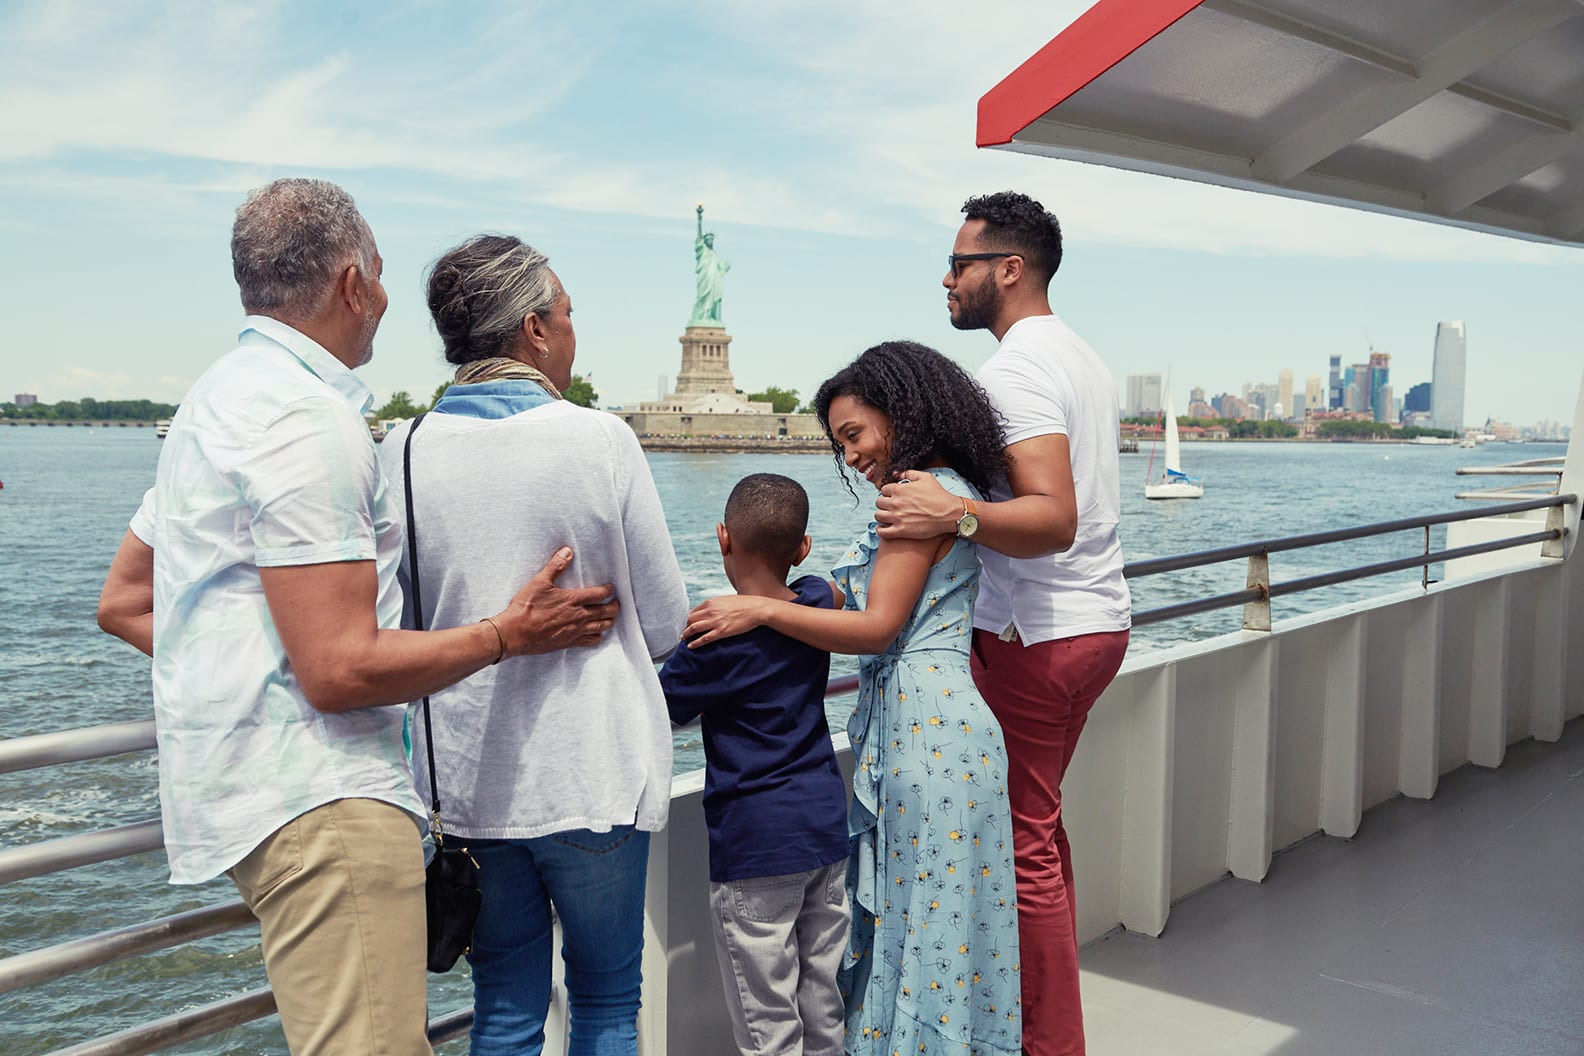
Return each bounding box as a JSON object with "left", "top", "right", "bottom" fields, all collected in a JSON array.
[{"left": 0, "top": 494, "right": 1578, "bottom": 1056}]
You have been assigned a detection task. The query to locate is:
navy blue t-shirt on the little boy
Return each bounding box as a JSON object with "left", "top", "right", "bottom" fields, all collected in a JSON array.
[{"left": 661, "top": 576, "right": 847, "bottom": 883}]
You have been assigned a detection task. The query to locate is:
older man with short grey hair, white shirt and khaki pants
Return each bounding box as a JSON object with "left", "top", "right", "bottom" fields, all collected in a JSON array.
[{"left": 100, "top": 179, "right": 616, "bottom": 1056}]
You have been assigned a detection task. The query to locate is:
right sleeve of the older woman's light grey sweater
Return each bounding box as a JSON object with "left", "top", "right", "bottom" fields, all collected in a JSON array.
[{"left": 608, "top": 420, "right": 687, "bottom": 659}]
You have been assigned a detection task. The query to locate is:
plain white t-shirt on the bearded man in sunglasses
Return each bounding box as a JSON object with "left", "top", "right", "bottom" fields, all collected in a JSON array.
[{"left": 974, "top": 315, "right": 1133, "bottom": 644}]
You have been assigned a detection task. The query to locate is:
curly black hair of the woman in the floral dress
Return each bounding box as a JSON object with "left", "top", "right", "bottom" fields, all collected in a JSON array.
[{"left": 814, "top": 340, "right": 1006, "bottom": 497}]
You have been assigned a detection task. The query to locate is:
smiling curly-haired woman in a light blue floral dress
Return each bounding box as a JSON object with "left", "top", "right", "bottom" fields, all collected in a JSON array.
[{"left": 684, "top": 342, "right": 1022, "bottom": 1056}]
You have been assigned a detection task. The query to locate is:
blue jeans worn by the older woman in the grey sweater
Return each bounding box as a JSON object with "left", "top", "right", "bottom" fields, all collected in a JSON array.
[{"left": 467, "top": 825, "right": 649, "bottom": 1056}]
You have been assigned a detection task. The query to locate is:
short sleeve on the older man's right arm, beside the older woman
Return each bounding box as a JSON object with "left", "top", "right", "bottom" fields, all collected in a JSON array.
[{"left": 233, "top": 396, "right": 380, "bottom": 568}]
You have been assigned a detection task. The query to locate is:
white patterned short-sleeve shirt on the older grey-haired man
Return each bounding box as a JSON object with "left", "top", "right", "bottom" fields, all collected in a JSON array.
[{"left": 131, "top": 315, "right": 421, "bottom": 883}]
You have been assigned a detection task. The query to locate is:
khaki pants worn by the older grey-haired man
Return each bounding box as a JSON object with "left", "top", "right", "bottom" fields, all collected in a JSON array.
[{"left": 227, "top": 800, "right": 432, "bottom": 1056}]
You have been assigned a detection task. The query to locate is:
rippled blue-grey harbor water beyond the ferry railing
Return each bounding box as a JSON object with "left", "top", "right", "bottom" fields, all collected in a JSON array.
[{"left": 0, "top": 427, "right": 1563, "bottom": 1056}]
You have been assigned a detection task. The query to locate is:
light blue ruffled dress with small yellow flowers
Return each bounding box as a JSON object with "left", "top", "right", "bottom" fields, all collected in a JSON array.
[{"left": 832, "top": 469, "right": 1022, "bottom": 1056}]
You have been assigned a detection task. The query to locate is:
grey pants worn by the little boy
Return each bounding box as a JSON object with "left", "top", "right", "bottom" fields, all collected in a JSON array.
[{"left": 710, "top": 861, "right": 849, "bottom": 1056}]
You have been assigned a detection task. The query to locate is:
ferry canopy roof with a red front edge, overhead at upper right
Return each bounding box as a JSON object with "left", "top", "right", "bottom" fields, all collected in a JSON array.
[{"left": 979, "top": 0, "right": 1584, "bottom": 245}]
